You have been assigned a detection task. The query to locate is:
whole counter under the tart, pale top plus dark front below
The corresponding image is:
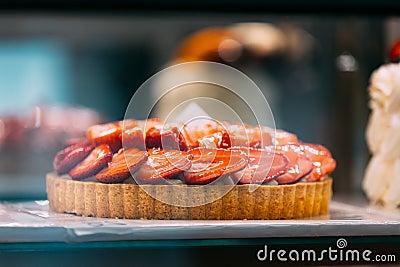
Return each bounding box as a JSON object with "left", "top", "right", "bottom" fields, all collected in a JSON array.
[{"left": 0, "top": 200, "right": 400, "bottom": 266}]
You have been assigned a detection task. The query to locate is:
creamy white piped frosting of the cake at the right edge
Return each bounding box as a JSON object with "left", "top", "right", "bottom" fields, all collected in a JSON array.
[{"left": 363, "top": 64, "right": 400, "bottom": 207}]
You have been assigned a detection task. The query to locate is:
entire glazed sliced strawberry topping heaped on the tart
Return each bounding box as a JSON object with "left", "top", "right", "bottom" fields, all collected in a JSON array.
[{"left": 53, "top": 118, "right": 336, "bottom": 185}]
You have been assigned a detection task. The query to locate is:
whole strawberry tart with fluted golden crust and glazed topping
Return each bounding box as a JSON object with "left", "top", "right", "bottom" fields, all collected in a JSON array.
[{"left": 47, "top": 119, "right": 336, "bottom": 220}]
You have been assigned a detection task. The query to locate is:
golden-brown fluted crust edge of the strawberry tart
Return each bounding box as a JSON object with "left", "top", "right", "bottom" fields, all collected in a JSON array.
[{"left": 46, "top": 173, "right": 332, "bottom": 220}]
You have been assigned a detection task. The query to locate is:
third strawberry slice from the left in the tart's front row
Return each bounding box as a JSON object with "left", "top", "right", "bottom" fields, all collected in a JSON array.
[{"left": 96, "top": 148, "right": 148, "bottom": 183}]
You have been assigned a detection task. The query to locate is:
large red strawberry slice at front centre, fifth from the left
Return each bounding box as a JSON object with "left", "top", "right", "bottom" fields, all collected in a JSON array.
[{"left": 184, "top": 148, "right": 247, "bottom": 184}]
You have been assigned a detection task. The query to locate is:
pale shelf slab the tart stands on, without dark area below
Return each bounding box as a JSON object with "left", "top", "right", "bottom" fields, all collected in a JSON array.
[{"left": 0, "top": 200, "right": 400, "bottom": 243}]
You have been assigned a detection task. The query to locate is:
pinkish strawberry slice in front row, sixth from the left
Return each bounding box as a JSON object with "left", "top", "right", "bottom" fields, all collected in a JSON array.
[{"left": 232, "top": 149, "right": 289, "bottom": 184}]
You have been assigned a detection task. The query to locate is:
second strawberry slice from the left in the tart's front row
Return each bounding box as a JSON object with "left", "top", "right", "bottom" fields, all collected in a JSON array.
[{"left": 69, "top": 144, "right": 113, "bottom": 180}]
